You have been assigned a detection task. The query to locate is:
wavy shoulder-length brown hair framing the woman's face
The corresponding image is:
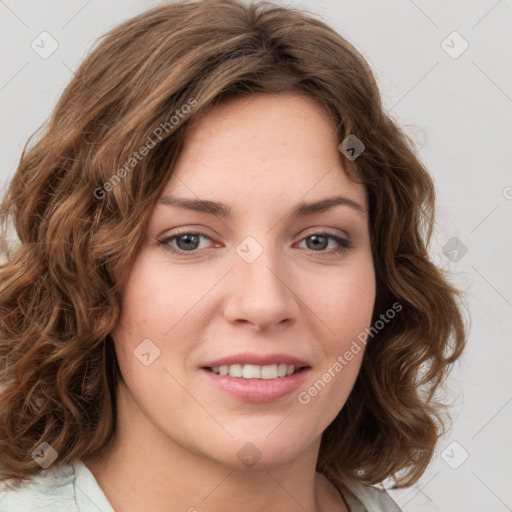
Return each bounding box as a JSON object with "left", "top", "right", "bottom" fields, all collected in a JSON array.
[{"left": 0, "top": 0, "right": 466, "bottom": 488}]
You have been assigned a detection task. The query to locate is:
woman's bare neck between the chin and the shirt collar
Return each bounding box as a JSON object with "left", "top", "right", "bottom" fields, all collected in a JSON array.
[{"left": 82, "top": 380, "right": 348, "bottom": 512}]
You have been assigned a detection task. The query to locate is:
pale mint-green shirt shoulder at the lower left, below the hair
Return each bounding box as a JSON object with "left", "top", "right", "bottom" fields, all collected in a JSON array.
[{"left": 0, "top": 460, "right": 114, "bottom": 512}]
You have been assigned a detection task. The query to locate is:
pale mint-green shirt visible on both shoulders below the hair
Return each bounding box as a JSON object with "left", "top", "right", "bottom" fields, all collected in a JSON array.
[{"left": 0, "top": 460, "right": 401, "bottom": 512}]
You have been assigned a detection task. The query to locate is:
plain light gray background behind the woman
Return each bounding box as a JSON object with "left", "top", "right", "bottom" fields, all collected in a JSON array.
[{"left": 0, "top": 0, "right": 512, "bottom": 512}]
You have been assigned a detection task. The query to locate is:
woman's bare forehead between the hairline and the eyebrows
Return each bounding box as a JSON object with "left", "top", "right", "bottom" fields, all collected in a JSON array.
[{"left": 162, "top": 93, "right": 366, "bottom": 209}]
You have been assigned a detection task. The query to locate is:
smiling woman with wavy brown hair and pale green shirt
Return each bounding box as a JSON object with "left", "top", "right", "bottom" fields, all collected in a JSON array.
[{"left": 0, "top": 0, "right": 465, "bottom": 512}]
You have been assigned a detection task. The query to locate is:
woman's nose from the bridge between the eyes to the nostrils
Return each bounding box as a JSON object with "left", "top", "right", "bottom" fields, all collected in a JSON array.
[{"left": 225, "top": 236, "right": 298, "bottom": 329}]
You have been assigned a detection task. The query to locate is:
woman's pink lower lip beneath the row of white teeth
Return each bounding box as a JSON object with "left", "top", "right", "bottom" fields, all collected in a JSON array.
[{"left": 201, "top": 368, "right": 309, "bottom": 403}]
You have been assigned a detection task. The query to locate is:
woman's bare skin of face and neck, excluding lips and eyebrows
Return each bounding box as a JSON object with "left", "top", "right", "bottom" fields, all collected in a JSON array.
[{"left": 84, "top": 93, "right": 376, "bottom": 512}]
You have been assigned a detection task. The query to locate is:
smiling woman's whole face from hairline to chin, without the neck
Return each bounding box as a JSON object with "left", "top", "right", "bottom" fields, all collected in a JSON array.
[{"left": 113, "top": 93, "right": 375, "bottom": 467}]
